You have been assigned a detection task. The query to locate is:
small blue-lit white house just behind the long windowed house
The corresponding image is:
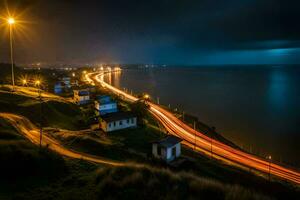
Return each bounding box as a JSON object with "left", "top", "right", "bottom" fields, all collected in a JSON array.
[{"left": 95, "top": 96, "right": 118, "bottom": 115}]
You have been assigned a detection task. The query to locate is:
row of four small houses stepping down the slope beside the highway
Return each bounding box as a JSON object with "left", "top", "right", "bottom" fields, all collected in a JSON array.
[{"left": 74, "top": 89, "right": 181, "bottom": 162}]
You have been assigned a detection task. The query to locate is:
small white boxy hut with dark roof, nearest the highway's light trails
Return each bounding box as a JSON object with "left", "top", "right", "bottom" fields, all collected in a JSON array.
[{"left": 152, "top": 135, "right": 182, "bottom": 162}]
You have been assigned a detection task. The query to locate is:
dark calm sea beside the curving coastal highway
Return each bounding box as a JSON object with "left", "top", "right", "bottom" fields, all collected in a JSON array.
[{"left": 106, "top": 66, "right": 300, "bottom": 167}]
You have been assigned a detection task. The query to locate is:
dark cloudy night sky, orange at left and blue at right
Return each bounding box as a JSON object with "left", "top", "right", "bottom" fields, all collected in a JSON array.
[{"left": 0, "top": 0, "right": 300, "bottom": 65}]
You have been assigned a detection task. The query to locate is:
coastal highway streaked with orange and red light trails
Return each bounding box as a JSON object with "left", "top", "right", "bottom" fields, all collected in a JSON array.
[{"left": 86, "top": 71, "right": 300, "bottom": 184}]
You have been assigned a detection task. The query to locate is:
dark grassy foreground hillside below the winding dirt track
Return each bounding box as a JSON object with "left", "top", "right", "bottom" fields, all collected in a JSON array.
[{"left": 0, "top": 119, "right": 278, "bottom": 200}]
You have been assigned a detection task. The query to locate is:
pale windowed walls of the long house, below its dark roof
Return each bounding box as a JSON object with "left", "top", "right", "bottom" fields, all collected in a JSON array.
[{"left": 101, "top": 117, "right": 137, "bottom": 132}]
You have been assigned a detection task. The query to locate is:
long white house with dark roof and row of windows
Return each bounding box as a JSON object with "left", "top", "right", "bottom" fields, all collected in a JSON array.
[{"left": 100, "top": 112, "right": 137, "bottom": 132}]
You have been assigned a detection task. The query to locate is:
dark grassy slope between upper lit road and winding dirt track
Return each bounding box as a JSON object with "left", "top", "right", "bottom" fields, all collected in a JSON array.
[{"left": 0, "top": 86, "right": 85, "bottom": 130}]
